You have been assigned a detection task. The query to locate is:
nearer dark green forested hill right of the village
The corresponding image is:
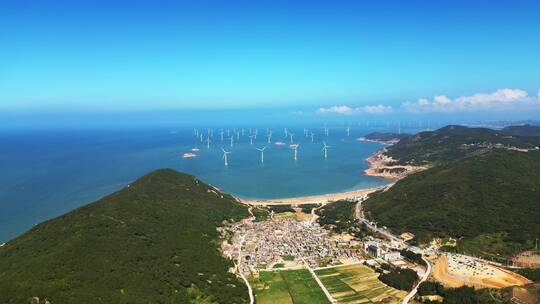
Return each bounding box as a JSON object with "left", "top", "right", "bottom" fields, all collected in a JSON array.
[{"left": 364, "top": 149, "right": 540, "bottom": 255}]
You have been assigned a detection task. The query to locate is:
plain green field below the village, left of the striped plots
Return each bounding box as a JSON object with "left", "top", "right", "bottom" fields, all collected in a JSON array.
[{"left": 250, "top": 269, "right": 329, "bottom": 304}]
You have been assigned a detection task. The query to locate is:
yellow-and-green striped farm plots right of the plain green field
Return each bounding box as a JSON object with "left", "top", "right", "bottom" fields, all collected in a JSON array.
[{"left": 315, "top": 264, "right": 407, "bottom": 304}]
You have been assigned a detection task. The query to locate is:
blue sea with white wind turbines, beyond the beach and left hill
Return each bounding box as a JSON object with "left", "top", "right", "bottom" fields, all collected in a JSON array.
[{"left": 0, "top": 128, "right": 387, "bottom": 242}]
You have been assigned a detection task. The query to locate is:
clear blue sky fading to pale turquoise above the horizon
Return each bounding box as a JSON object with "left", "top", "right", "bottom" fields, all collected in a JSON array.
[{"left": 0, "top": 0, "right": 540, "bottom": 115}]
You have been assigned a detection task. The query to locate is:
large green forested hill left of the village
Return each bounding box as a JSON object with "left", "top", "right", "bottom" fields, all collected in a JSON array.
[{"left": 0, "top": 170, "right": 248, "bottom": 304}]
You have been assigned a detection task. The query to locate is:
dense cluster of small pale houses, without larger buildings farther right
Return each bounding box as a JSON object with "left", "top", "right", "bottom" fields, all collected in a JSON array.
[{"left": 222, "top": 219, "right": 359, "bottom": 274}]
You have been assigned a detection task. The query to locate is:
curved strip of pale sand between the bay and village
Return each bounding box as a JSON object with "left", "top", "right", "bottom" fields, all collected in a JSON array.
[{"left": 239, "top": 185, "right": 389, "bottom": 206}]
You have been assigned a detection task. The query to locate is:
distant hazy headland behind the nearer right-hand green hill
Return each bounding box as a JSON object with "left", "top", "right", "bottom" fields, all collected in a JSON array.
[{"left": 386, "top": 125, "right": 540, "bottom": 165}]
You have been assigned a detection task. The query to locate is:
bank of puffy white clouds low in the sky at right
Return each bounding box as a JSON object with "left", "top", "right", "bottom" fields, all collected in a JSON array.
[{"left": 402, "top": 89, "right": 540, "bottom": 113}]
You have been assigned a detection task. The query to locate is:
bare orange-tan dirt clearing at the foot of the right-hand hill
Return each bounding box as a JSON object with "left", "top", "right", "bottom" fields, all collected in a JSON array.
[{"left": 433, "top": 255, "right": 531, "bottom": 288}]
